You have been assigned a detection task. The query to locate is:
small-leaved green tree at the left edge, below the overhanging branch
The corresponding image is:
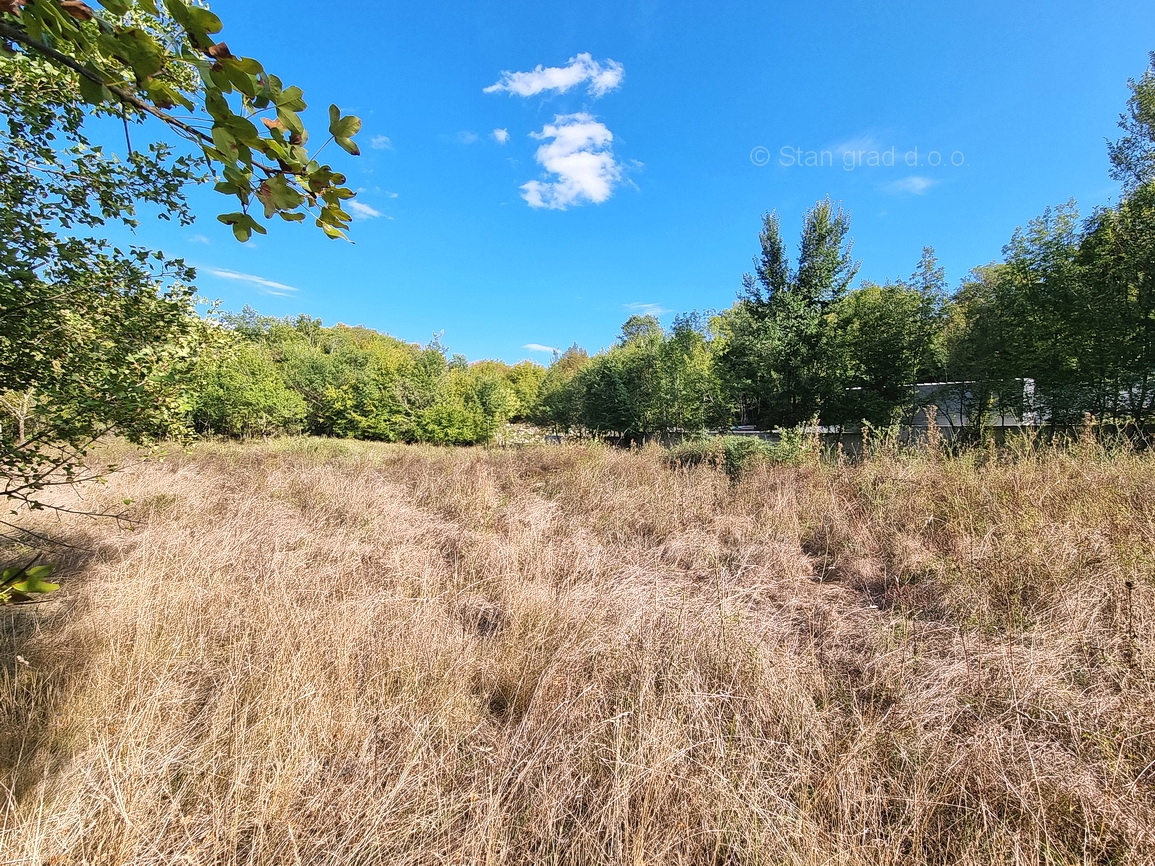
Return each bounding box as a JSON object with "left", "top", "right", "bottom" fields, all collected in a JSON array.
[{"left": 0, "top": 50, "right": 201, "bottom": 528}]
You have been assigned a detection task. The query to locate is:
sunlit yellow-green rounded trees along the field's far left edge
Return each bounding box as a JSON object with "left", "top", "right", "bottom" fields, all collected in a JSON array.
[{"left": 186, "top": 309, "right": 545, "bottom": 445}]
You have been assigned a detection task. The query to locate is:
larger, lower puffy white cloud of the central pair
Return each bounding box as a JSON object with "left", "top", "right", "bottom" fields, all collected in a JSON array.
[{"left": 521, "top": 112, "right": 621, "bottom": 210}]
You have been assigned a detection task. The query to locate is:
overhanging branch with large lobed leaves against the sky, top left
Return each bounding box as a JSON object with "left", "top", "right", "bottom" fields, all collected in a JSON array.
[{"left": 0, "top": 0, "right": 360, "bottom": 240}]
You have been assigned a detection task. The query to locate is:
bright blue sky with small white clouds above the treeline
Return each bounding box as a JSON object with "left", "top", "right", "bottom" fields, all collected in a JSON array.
[{"left": 119, "top": 0, "right": 1155, "bottom": 363}]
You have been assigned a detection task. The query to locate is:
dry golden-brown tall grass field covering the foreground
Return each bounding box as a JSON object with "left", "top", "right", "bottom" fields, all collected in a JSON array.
[{"left": 0, "top": 440, "right": 1155, "bottom": 866}]
